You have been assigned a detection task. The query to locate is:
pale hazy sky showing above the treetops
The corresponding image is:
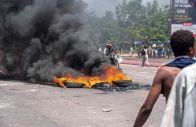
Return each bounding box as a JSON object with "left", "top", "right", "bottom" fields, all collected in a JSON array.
[{"left": 83, "top": 0, "right": 170, "bottom": 16}]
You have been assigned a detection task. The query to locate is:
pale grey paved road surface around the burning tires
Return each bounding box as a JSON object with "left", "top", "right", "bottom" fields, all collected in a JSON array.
[{"left": 0, "top": 65, "right": 165, "bottom": 127}]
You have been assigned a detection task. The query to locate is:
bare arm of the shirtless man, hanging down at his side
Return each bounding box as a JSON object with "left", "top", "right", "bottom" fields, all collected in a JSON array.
[{"left": 134, "top": 68, "right": 164, "bottom": 127}]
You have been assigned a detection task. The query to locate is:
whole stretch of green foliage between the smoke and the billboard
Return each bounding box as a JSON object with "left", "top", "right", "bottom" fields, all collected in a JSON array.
[{"left": 87, "top": 0, "right": 169, "bottom": 45}]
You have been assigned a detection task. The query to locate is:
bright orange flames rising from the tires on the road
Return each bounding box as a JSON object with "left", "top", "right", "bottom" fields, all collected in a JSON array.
[{"left": 54, "top": 66, "right": 131, "bottom": 88}]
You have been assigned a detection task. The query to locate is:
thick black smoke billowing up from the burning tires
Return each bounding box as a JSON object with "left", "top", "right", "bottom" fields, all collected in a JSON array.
[{"left": 0, "top": 0, "right": 109, "bottom": 81}]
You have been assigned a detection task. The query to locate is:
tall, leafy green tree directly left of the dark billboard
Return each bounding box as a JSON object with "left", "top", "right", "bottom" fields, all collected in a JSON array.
[{"left": 116, "top": 0, "right": 169, "bottom": 41}]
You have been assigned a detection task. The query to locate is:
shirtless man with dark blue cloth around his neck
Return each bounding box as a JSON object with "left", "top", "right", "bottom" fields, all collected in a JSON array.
[{"left": 134, "top": 30, "right": 196, "bottom": 127}]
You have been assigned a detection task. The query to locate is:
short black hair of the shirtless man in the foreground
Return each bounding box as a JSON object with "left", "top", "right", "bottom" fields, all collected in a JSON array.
[{"left": 170, "top": 30, "right": 195, "bottom": 57}]
